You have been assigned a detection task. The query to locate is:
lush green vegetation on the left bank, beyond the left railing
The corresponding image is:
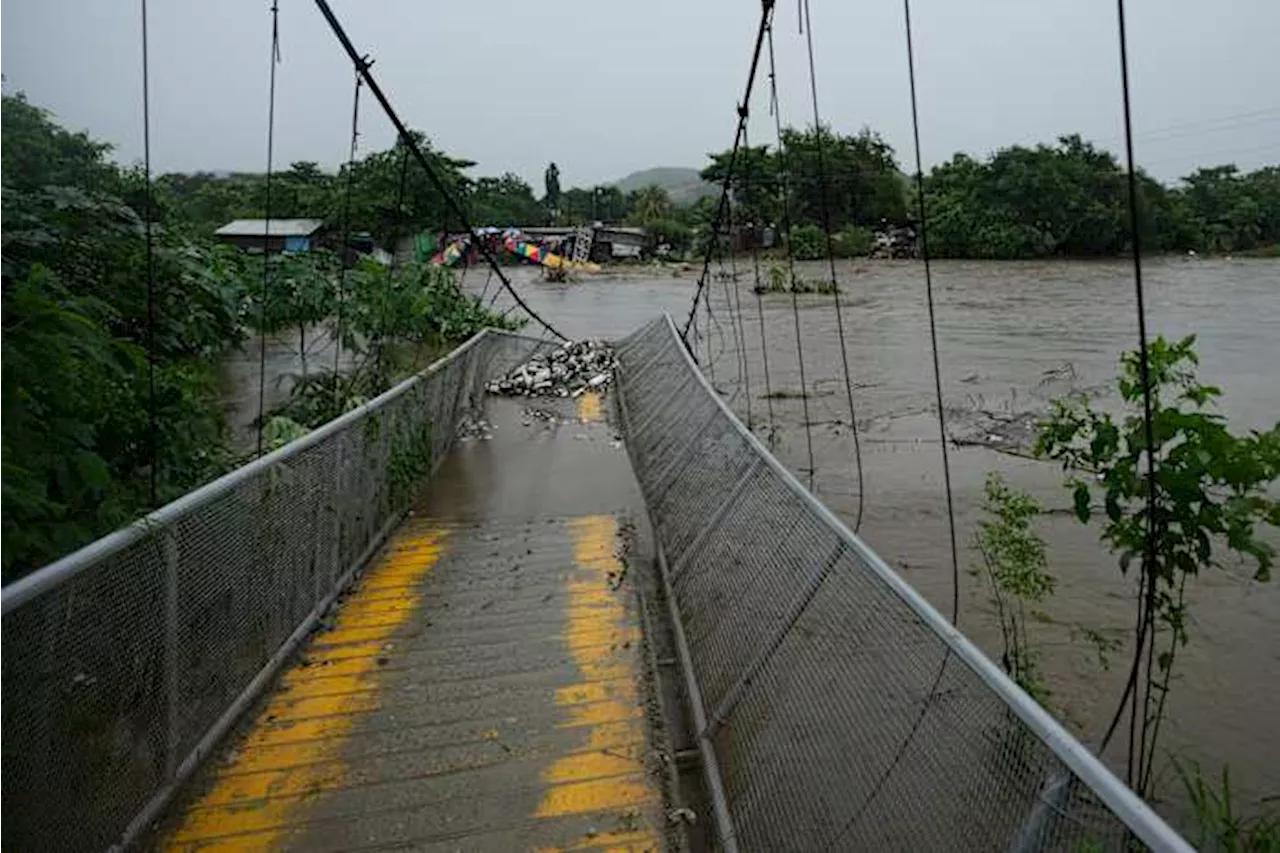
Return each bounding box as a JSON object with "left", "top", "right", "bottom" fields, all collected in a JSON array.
[{"left": 0, "top": 96, "right": 511, "bottom": 583}]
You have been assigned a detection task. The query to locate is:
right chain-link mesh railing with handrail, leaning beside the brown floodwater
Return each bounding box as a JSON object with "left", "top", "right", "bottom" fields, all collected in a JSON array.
[{"left": 618, "top": 318, "right": 1190, "bottom": 852}]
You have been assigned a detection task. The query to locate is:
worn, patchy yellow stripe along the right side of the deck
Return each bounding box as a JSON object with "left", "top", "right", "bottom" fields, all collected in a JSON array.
[{"left": 534, "top": 514, "right": 658, "bottom": 849}]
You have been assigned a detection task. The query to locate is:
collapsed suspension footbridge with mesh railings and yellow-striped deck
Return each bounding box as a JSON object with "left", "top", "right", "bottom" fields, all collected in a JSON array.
[{"left": 0, "top": 0, "right": 1189, "bottom": 850}]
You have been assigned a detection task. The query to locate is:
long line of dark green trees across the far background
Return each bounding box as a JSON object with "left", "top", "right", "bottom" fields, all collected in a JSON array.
[{"left": 145, "top": 112, "right": 1280, "bottom": 259}]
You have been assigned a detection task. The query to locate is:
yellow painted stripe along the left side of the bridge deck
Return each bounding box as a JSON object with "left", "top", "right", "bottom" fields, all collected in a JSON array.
[{"left": 161, "top": 524, "right": 445, "bottom": 850}]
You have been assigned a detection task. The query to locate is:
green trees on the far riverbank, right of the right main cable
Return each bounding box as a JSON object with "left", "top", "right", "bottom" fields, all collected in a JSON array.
[{"left": 701, "top": 122, "right": 1280, "bottom": 260}]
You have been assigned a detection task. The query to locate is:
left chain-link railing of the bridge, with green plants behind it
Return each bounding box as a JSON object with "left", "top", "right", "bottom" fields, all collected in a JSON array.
[{"left": 0, "top": 330, "right": 550, "bottom": 850}]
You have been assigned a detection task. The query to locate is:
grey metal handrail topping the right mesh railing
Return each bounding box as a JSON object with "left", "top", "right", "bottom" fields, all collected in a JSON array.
[{"left": 663, "top": 314, "right": 1194, "bottom": 853}]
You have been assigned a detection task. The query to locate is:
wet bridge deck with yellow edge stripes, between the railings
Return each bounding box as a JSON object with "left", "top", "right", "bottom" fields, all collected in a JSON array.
[{"left": 159, "top": 396, "right": 664, "bottom": 850}]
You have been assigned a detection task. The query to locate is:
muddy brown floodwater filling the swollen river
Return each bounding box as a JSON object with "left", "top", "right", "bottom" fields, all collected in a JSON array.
[{"left": 478, "top": 259, "right": 1280, "bottom": 819}]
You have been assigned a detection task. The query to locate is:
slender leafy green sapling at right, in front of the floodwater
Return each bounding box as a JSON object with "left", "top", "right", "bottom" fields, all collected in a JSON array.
[{"left": 1036, "top": 337, "right": 1280, "bottom": 794}]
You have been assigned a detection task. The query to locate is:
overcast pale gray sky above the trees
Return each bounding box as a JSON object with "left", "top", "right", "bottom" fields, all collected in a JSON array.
[{"left": 0, "top": 0, "right": 1280, "bottom": 186}]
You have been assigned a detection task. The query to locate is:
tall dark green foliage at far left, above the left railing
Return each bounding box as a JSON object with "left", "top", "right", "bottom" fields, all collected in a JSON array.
[{"left": 0, "top": 96, "right": 242, "bottom": 581}]
